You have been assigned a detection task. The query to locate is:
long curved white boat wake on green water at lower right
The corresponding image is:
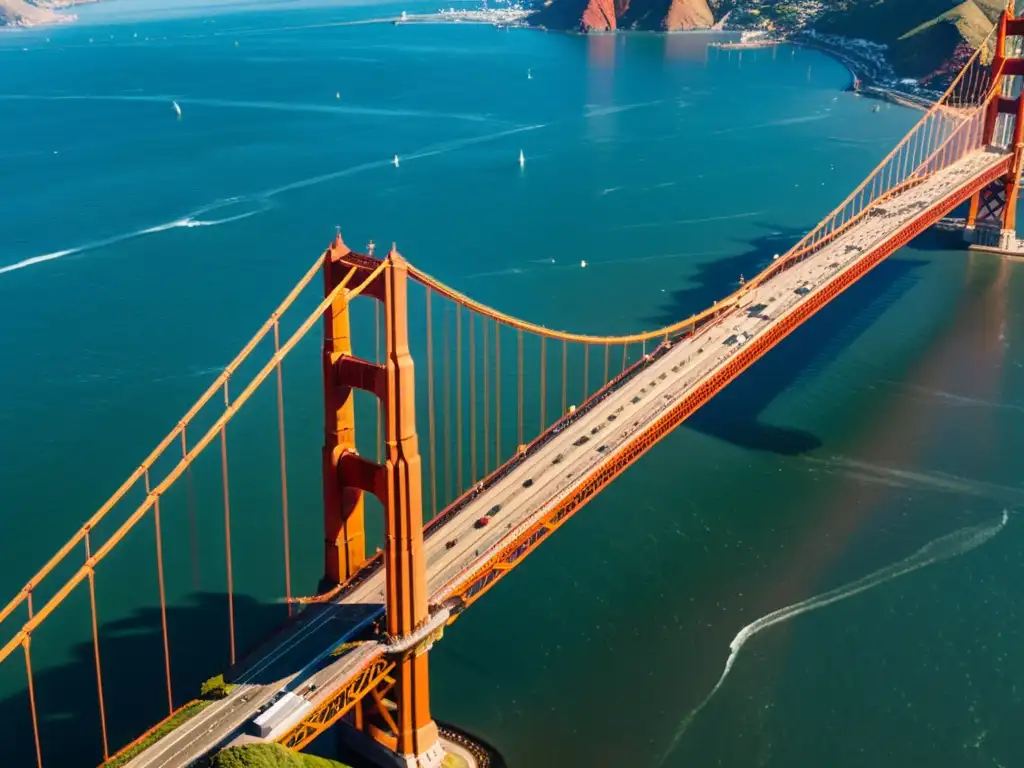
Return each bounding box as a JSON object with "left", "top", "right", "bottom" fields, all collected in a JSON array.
[{"left": 655, "top": 510, "right": 1010, "bottom": 766}]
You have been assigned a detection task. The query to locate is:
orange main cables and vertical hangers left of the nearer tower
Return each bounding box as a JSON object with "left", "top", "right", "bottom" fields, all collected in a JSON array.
[{"left": 0, "top": 247, "right": 384, "bottom": 768}]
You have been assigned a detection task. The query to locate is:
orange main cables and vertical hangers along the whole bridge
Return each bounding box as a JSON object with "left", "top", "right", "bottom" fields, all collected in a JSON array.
[{"left": 0, "top": 18, "right": 997, "bottom": 766}]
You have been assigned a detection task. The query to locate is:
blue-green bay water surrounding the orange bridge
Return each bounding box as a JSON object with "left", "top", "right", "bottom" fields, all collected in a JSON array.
[{"left": 0, "top": 0, "right": 1024, "bottom": 768}]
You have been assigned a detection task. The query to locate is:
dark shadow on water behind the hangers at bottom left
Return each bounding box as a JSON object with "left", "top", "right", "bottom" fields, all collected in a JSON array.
[{"left": 0, "top": 593, "right": 287, "bottom": 768}]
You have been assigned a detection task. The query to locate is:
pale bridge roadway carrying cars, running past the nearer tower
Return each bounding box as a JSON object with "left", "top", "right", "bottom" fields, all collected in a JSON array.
[{"left": 129, "top": 145, "right": 1008, "bottom": 768}]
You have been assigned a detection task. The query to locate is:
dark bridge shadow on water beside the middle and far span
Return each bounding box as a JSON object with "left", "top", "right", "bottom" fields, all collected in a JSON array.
[{"left": 650, "top": 226, "right": 933, "bottom": 456}]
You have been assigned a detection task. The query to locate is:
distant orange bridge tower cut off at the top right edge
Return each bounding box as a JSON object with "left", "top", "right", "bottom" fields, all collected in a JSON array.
[{"left": 964, "top": 5, "right": 1024, "bottom": 254}]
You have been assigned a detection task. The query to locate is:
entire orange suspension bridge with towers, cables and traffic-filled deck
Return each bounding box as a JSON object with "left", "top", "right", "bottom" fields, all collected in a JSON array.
[{"left": 6, "top": 10, "right": 1024, "bottom": 768}]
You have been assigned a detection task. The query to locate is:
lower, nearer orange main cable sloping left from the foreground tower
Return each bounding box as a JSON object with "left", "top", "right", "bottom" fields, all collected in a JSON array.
[{"left": 0, "top": 256, "right": 384, "bottom": 662}]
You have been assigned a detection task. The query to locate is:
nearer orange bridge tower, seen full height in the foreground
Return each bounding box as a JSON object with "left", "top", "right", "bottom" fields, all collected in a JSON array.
[{"left": 322, "top": 233, "right": 444, "bottom": 768}]
